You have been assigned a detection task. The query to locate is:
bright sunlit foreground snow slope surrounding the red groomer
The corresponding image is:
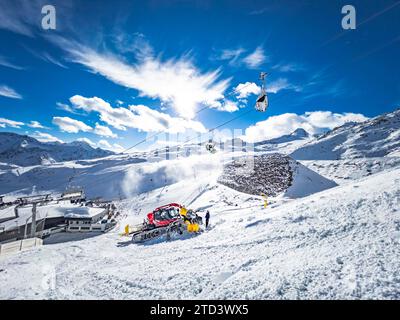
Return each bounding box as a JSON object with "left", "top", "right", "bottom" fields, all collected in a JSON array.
[{"left": 0, "top": 162, "right": 400, "bottom": 299}]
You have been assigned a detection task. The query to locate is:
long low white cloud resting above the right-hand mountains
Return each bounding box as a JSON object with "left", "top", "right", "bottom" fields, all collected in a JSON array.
[{"left": 243, "top": 111, "right": 368, "bottom": 142}]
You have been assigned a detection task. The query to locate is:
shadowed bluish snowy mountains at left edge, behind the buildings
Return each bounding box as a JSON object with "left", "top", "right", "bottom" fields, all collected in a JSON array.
[{"left": 0, "top": 132, "right": 114, "bottom": 166}]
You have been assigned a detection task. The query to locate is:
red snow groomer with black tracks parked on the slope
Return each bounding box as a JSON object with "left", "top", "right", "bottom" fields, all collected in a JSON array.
[{"left": 132, "top": 203, "right": 202, "bottom": 242}]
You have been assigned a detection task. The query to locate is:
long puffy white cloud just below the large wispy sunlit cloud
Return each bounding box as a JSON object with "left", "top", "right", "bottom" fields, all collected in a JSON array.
[{"left": 70, "top": 95, "right": 206, "bottom": 133}]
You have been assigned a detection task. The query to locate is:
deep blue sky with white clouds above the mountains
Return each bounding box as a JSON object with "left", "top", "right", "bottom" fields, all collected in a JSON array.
[{"left": 0, "top": 0, "right": 400, "bottom": 151}]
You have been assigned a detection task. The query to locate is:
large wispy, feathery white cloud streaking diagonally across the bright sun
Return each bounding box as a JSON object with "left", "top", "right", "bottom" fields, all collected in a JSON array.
[{"left": 53, "top": 38, "right": 230, "bottom": 119}]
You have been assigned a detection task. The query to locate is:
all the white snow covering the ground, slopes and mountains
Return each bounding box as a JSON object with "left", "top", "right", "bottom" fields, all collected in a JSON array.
[{"left": 0, "top": 111, "right": 400, "bottom": 299}]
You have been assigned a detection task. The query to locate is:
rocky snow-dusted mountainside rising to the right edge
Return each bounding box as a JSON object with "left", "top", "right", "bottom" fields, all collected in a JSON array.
[{"left": 291, "top": 109, "right": 400, "bottom": 160}]
